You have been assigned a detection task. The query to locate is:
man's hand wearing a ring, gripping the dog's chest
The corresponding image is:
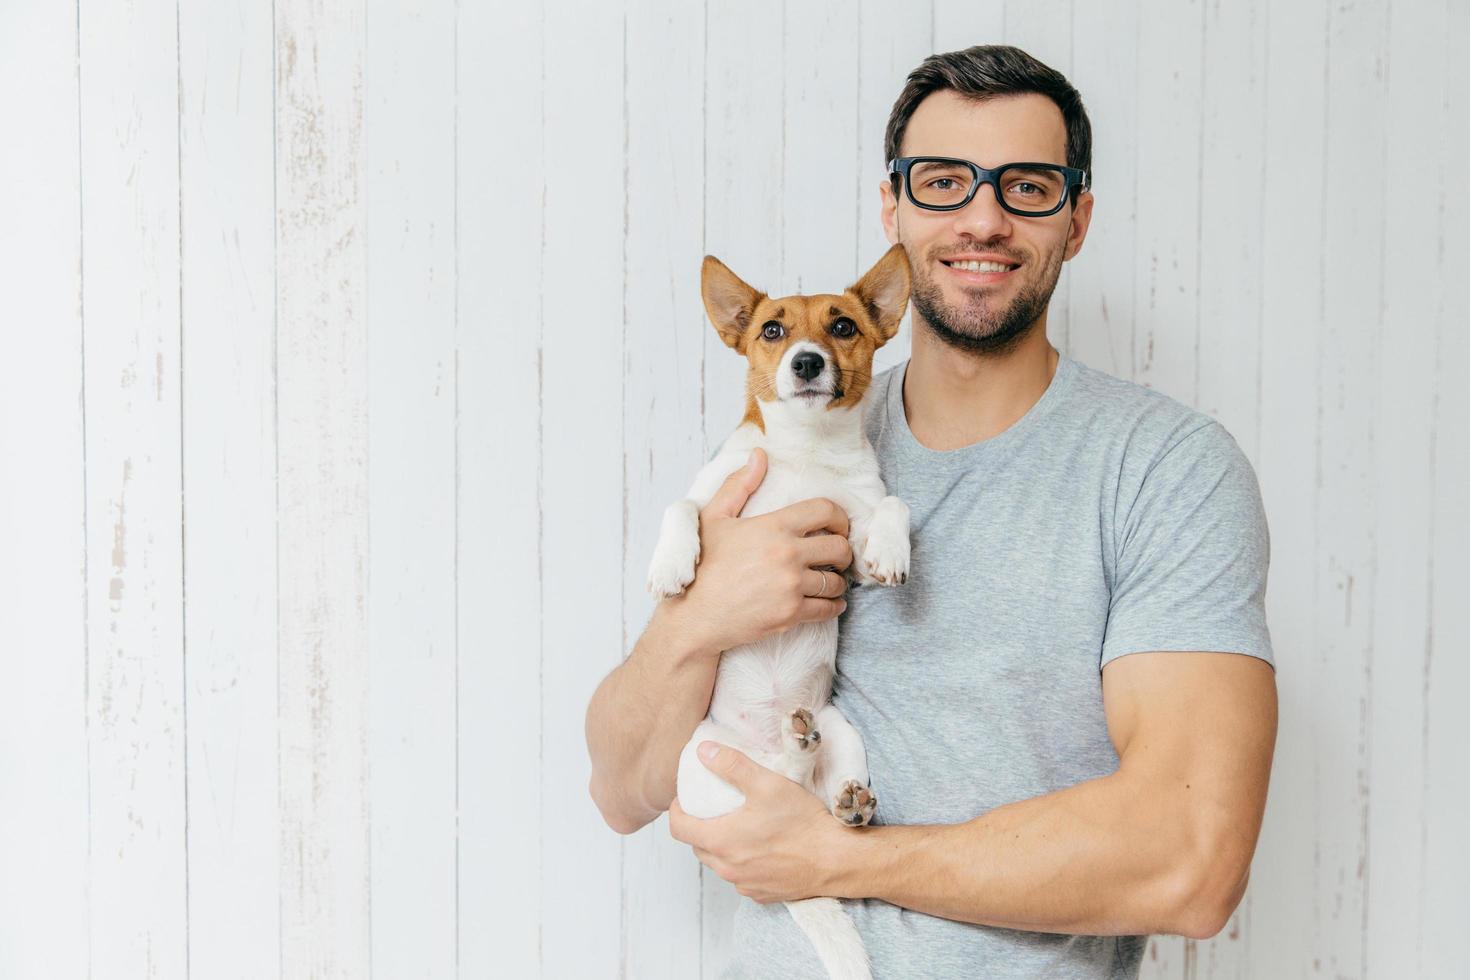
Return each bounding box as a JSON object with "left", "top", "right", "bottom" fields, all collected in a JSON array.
[{"left": 659, "top": 450, "right": 853, "bottom": 654}]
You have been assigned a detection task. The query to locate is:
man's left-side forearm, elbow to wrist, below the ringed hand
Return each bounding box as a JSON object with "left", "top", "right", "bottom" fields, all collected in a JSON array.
[{"left": 587, "top": 605, "right": 719, "bottom": 833}]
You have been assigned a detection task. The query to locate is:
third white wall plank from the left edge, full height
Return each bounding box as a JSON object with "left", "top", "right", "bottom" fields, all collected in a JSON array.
[{"left": 178, "top": 3, "right": 281, "bottom": 977}]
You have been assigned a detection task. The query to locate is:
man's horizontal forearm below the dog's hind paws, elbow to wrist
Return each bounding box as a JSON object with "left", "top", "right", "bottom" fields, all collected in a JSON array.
[{"left": 826, "top": 770, "right": 1227, "bottom": 937}]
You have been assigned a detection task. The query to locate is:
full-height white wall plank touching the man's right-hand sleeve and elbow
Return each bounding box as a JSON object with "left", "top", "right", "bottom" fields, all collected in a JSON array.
[{"left": 1242, "top": 4, "right": 1341, "bottom": 976}]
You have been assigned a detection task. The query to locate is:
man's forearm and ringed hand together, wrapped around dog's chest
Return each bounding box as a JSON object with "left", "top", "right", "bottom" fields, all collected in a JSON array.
[{"left": 587, "top": 450, "right": 853, "bottom": 833}]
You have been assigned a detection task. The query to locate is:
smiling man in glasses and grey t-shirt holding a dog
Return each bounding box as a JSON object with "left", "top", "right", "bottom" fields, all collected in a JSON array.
[{"left": 588, "top": 46, "right": 1276, "bottom": 977}]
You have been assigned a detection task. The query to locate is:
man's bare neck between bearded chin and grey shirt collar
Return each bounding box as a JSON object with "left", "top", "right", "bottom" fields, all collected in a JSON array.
[{"left": 903, "top": 319, "right": 1057, "bottom": 450}]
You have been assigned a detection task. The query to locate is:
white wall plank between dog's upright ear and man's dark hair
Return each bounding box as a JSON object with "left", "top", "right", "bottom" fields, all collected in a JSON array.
[{"left": 844, "top": 0, "right": 933, "bottom": 375}]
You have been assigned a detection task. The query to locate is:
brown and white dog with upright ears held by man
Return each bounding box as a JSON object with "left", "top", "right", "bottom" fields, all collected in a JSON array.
[{"left": 648, "top": 245, "right": 911, "bottom": 980}]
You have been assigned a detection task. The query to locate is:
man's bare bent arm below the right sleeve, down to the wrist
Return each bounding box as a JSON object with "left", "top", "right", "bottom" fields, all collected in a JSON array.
[{"left": 822, "top": 652, "right": 1276, "bottom": 939}]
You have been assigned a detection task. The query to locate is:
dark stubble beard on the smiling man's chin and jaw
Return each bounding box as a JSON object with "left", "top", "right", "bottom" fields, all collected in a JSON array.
[{"left": 913, "top": 248, "right": 1063, "bottom": 357}]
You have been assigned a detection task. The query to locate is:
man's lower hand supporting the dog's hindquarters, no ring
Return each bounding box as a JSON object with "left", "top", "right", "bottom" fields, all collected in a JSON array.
[{"left": 669, "top": 742, "right": 853, "bottom": 905}]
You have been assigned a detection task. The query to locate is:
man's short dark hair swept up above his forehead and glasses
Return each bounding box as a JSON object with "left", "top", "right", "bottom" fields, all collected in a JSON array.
[{"left": 883, "top": 44, "right": 1092, "bottom": 185}]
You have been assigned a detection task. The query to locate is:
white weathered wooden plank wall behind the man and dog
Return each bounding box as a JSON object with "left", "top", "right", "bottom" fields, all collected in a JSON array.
[{"left": 0, "top": 0, "right": 1470, "bottom": 979}]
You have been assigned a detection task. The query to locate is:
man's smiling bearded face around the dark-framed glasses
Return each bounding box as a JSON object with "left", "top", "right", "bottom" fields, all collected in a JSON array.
[{"left": 882, "top": 91, "right": 1092, "bottom": 353}]
